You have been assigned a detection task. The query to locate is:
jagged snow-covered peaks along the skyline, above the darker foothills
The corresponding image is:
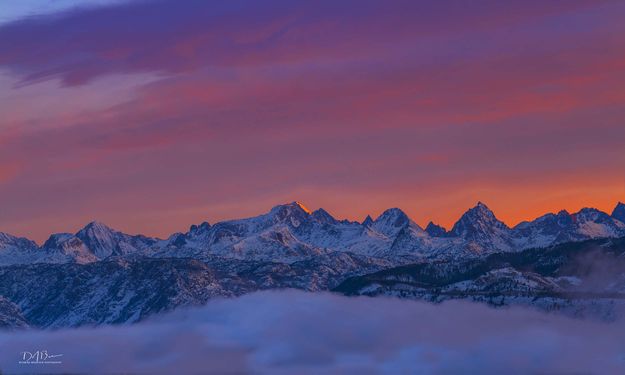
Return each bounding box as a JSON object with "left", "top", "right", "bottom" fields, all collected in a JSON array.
[{"left": 0, "top": 202, "right": 625, "bottom": 265}]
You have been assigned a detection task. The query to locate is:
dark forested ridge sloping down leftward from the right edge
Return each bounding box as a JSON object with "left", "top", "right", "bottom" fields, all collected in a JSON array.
[{"left": 334, "top": 238, "right": 625, "bottom": 319}]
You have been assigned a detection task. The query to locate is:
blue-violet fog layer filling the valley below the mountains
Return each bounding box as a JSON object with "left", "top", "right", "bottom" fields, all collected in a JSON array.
[{"left": 0, "top": 291, "right": 625, "bottom": 374}]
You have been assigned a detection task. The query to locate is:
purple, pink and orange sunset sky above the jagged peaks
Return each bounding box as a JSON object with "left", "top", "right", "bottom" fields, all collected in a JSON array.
[{"left": 0, "top": 0, "right": 625, "bottom": 241}]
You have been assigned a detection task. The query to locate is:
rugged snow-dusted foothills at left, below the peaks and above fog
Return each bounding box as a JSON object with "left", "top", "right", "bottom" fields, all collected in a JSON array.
[{"left": 0, "top": 254, "right": 391, "bottom": 328}]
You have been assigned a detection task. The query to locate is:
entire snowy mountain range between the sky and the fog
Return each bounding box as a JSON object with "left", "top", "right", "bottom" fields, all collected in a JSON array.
[{"left": 0, "top": 202, "right": 625, "bottom": 328}]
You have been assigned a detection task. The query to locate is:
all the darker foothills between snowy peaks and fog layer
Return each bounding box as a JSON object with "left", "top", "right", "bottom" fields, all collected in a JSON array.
[{"left": 0, "top": 238, "right": 625, "bottom": 328}]
